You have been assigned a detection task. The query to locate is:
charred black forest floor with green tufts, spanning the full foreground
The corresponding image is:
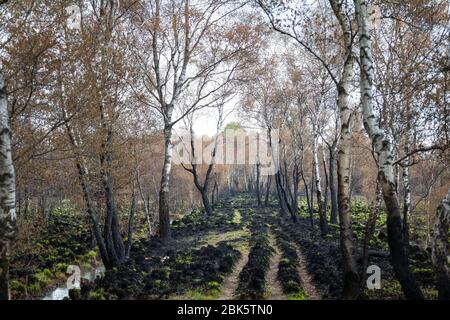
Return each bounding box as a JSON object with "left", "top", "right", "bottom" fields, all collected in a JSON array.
[{"left": 13, "top": 194, "right": 436, "bottom": 300}]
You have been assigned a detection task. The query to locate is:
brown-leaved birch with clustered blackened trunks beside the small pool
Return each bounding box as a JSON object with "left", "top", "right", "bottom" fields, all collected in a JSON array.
[{"left": 49, "top": 0, "right": 134, "bottom": 269}]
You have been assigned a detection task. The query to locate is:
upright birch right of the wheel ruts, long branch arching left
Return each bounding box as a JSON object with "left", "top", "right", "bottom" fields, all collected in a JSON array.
[{"left": 258, "top": 0, "right": 359, "bottom": 298}]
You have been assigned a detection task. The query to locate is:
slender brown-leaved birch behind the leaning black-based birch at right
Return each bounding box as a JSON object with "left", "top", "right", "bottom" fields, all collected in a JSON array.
[{"left": 372, "top": 1, "right": 449, "bottom": 250}]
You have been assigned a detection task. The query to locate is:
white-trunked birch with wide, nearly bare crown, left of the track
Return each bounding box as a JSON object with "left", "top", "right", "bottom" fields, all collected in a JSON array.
[{"left": 130, "top": 0, "right": 250, "bottom": 242}]
